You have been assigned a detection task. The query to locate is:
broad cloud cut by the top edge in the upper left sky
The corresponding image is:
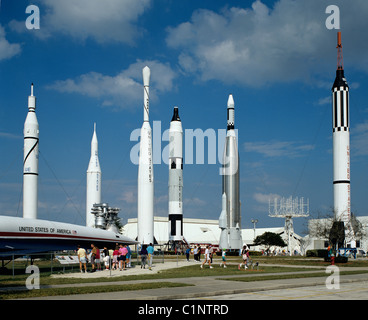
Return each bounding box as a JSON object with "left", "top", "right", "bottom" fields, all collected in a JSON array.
[{"left": 10, "top": 0, "right": 151, "bottom": 44}]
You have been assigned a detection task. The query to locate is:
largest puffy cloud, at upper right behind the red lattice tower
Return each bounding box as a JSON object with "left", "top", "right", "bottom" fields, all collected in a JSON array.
[{"left": 166, "top": 0, "right": 368, "bottom": 86}]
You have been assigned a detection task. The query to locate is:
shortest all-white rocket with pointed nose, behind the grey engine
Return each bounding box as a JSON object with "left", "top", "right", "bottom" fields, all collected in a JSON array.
[{"left": 86, "top": 124, "right": 101, "bottom": 227}]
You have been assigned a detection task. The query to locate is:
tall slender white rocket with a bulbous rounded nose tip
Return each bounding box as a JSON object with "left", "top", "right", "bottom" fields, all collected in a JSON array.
[{"left": 137, "top": 66, "right": 154, "bottom": 245}]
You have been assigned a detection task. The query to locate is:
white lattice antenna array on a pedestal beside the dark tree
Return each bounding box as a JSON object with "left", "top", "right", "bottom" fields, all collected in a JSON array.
[{"left": 268, "top": 196, "right": 309, "bottom": 255}]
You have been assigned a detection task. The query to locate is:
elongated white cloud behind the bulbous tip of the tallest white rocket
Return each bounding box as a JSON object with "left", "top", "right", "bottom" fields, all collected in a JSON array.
[{"left": 48, "top": 60, "right": 175, "bottom": 108}]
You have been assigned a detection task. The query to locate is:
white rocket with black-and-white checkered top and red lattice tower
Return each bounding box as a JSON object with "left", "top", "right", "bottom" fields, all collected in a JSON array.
[{"left": 331, "top": 31, "right": 351, "bottom": 242}]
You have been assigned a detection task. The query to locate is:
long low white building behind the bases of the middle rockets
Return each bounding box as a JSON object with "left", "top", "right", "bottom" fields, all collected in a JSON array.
[{"left": 123, "top": 217, "right": 301, "bottom": 252}]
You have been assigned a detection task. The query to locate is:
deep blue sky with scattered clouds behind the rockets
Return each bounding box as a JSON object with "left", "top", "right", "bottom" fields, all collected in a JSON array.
[{"left": 0, "top": 0, "right": 368, "bottom": 233}]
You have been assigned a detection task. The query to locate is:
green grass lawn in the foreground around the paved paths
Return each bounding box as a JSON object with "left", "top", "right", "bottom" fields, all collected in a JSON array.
[{"left": 0, "top": 256, "right": 368, "bottom": 299}]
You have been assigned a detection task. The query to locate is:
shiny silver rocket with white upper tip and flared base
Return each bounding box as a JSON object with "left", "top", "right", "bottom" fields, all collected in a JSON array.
[{"left": 219, "top": 94, "right": 243, "bottom": 250}]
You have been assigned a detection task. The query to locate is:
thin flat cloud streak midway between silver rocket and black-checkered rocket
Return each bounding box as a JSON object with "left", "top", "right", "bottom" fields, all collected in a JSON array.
[{"left": 244, "top": 141, "right": 315, "bottom": 158}]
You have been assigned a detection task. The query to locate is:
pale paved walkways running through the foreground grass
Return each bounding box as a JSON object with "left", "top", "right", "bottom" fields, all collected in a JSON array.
[{"left": 9, "top": 261, "right": 368, "bottom": 300}]
